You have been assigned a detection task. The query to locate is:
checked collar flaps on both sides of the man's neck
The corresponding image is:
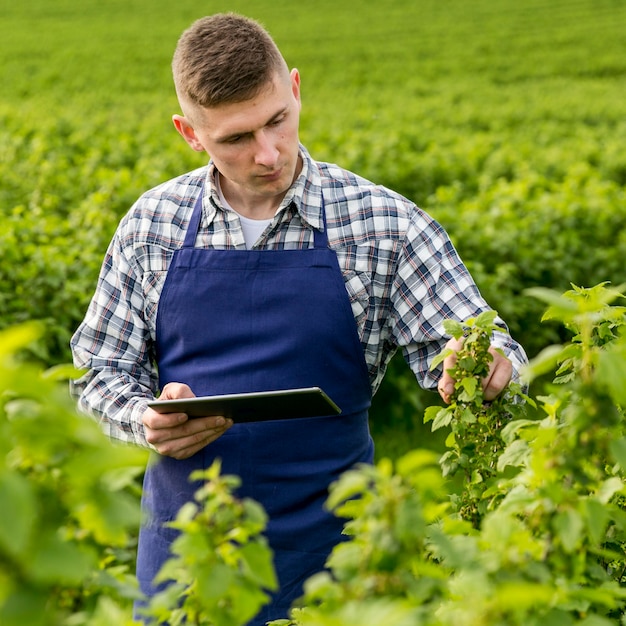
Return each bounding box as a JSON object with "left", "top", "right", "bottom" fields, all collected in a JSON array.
[{"left": 205, "top": 144, "right": 324, "bottom": 230}]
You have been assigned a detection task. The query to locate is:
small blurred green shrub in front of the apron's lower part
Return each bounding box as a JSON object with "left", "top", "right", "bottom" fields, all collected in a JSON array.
[{"left": 145, "top": 461, "right": 278, "bottom": 626}]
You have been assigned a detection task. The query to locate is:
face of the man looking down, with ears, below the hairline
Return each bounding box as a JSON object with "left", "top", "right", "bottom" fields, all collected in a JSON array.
[{"left": 173, "top": 70, "right": 301, "bottom": 208}]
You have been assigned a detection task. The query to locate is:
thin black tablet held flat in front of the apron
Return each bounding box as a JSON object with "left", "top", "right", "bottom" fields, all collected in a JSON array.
[{"left": 148, "top": 387, "right": 341, "bottom": 422}]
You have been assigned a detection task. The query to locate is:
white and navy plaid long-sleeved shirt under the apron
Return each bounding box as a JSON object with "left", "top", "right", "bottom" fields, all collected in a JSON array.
[{"left": 71, "top": 147, "right": 526, "bottom": 445}]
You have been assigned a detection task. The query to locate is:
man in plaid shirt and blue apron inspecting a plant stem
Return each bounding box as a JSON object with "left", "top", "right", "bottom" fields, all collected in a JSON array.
[{"left": 72, "top": 14, "right": 526, "bottom": 624}]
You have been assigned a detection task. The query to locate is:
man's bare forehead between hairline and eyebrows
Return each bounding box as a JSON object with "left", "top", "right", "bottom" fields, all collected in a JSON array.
[{"left": 191, "top": 77, "right": 293, "bottom": 140}]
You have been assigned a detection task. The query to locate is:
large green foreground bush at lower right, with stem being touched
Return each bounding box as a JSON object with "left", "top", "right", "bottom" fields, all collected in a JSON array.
[{"left": 277, "top": 285, "right": 626, "bottom": 626}]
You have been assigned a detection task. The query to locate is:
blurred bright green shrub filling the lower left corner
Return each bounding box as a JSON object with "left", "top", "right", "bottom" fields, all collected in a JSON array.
[{"left": 0, "top": 326, "right": 145, "bottom": 626}]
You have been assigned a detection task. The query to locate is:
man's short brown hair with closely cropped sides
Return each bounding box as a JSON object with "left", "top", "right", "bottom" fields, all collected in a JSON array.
[{"left": 172, "top": 13, "right": 287, "bottom": 107}]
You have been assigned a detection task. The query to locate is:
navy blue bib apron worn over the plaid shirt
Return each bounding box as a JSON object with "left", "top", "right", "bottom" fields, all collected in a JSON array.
[{"left": 137, "top": 183, "right": 373, "bottom": 626}]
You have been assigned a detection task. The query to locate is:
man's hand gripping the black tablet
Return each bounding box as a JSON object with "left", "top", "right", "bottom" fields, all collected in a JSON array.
[{"left": 142, "top": 383, "right": 233, "bottom": 459}]
